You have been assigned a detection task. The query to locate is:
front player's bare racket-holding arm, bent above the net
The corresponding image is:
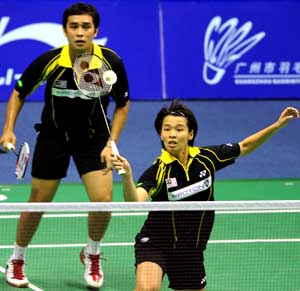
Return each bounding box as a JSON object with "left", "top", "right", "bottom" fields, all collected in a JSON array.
[{"left": 111, "top": 155, "right": 148, "bottom": 202}]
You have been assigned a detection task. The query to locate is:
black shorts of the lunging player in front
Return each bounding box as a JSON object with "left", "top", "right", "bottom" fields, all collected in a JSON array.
[{"left": 135, "top": 234, "right": 206, "bottom": 290}]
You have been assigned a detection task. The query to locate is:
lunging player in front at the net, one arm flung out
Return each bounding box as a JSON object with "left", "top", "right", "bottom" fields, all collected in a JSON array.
[{"left": 112, "top": 100, "right": 299, "bottom": 291}]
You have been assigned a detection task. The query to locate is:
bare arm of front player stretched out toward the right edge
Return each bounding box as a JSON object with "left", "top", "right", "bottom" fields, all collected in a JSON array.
[{"left": 239, "top": 107, "right": 300, "bottom": 156}]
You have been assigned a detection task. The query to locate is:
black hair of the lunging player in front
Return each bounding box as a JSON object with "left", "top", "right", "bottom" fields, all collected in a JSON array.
[{"left": 154, "top": 99, "right": 198, "bottom": 146}]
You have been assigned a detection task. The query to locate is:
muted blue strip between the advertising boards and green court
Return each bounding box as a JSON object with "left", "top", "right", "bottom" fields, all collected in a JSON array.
[{"left": 0, "top": 100, "right": 300, "bottom": 184}]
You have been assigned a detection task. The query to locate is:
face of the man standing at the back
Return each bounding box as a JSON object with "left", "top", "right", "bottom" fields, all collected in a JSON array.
[{"left": 64, "top": 14, "right": 98, "bottom": 55}]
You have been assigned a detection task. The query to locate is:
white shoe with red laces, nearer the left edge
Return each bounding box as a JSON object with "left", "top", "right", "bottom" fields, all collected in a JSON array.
[{"left": 5, "top": 259, "right": 29, "bottom": 288}]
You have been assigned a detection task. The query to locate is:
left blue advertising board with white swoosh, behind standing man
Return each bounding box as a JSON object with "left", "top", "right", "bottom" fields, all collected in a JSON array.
[{"left": 0, "top": 0, "right": 161, "bottom": 100}]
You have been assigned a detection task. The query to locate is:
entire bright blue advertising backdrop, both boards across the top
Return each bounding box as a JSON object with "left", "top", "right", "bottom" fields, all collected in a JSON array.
[{"left": 0, "top": 0, "right": 300, "bottom": 101}]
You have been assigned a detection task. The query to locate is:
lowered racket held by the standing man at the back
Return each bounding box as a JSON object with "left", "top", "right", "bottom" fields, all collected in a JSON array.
[{"left": 0, "top": 142, "right": 30, "bottom": 180}]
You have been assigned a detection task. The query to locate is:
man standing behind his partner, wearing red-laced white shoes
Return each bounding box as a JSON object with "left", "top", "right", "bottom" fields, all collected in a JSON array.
[{"left": 0, "top": 3, "right": 129, "bottom": 288}]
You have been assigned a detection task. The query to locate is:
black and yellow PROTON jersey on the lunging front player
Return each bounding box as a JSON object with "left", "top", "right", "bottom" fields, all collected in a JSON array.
[{"left": 137, "top": 143, "right": 240, "bottom": 249}]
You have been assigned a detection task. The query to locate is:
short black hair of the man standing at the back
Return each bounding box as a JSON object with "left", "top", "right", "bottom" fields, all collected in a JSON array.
[{"left": 62, "top": 2, "right": 100, "bottom": 29}]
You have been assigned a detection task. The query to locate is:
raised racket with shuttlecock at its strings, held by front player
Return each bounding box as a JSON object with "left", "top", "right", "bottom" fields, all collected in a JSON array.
[{"left": 73, "top": 54, "right": 125, "bottom": 175}]
